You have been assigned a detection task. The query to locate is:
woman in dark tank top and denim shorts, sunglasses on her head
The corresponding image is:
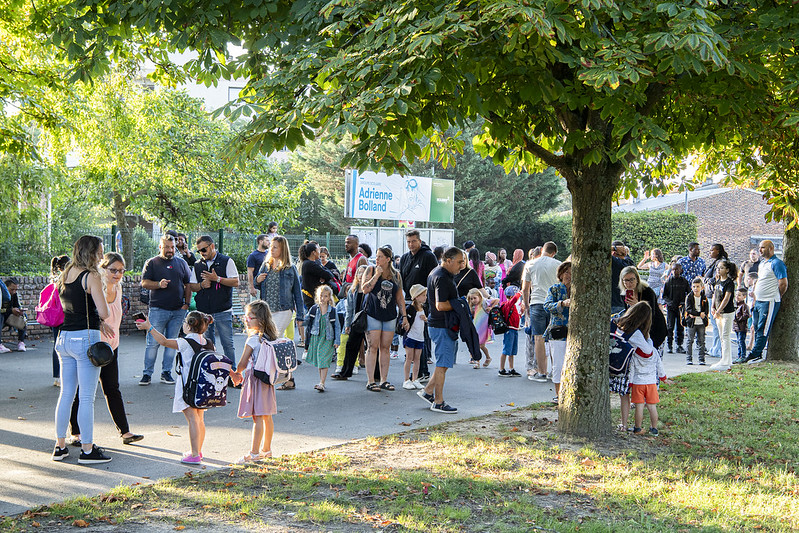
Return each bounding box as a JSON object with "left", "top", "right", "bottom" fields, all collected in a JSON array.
[{"left": 361, "top": 247, "right": 409, "bottom": 392}]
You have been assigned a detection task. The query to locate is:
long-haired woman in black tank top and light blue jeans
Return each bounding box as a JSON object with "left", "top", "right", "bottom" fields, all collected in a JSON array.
[{"left": 53, "top": 235, "right": 115, "bottom": 464}]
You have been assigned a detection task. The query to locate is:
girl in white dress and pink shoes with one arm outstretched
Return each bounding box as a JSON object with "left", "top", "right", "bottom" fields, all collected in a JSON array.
[{"left": 136, "top": 311, "right": 214, "bottom": 464}]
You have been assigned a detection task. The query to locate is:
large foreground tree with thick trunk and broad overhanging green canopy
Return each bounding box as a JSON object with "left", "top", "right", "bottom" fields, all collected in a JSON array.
[{"left": 55, "top": 0, "right": 789, "bottom": 436}]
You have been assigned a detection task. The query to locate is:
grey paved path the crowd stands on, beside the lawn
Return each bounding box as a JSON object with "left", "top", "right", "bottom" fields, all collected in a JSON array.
[{"left": 0, "top": 328, "right": 712, "bottom": 515}]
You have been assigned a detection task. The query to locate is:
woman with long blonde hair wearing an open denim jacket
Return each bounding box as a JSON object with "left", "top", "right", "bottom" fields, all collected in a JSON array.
[{"left": 254, "top": 235, "right": 305, "bottom": 338}]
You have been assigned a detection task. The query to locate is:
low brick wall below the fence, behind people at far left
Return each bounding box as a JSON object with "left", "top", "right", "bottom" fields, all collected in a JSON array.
[{"left": 3, "top": 273, "right": 249, "bottom": 343}]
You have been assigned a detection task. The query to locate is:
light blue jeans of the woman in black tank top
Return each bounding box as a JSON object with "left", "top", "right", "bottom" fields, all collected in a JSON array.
[{"left": 55, "top": 329, "right": 100, "bottom": 444}]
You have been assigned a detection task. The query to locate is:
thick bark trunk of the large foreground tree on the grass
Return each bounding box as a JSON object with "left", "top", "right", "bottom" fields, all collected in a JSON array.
[{"left": 559, "top": 166, "right": 618, "bottom": 437}]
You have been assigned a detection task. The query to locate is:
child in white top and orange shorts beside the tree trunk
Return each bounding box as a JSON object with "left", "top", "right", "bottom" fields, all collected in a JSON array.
[{"left": 617, "top": 302, "right": 666, "bottom": 436}]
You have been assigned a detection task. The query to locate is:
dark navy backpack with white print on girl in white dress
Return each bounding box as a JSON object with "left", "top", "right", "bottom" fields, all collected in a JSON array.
[{"left": 175, "top": 338, "right": 233, "bottom": 409}]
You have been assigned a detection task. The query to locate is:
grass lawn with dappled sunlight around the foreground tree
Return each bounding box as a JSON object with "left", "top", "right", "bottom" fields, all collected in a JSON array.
[{"left": 0, "top": 363, "right": 799, "bottom": 532}]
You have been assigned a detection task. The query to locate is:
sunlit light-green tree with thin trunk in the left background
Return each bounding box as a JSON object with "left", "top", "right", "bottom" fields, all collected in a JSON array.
[{"left": 49, "top": 76, "right": 302, "bottom": 264}]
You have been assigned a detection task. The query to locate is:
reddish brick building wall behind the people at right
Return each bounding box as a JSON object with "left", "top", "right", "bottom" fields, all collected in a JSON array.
[{"left": 663, "top": 189, "right": 785, "bottom": 266}]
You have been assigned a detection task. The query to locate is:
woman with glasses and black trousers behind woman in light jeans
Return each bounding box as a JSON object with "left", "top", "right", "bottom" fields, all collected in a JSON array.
[{"left": 70, "top": 252, "right": 144, "bottom": 446}]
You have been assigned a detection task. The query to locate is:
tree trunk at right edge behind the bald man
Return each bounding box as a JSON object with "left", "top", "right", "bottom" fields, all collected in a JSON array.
[{"left": 766, "top": 222, "right": 799, "bottom": 361}]
